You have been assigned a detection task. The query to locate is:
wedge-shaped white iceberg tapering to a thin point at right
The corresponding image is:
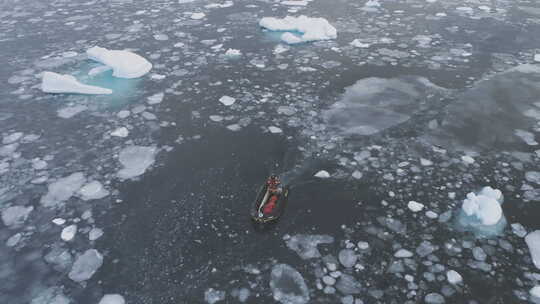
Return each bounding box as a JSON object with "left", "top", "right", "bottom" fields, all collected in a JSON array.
[{"left": 41, "top": 72, "right": 112, "bottom": 95}]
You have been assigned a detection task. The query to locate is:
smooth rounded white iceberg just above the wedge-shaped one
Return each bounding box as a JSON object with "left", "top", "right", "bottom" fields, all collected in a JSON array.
[{"left": 86, "top": 46, "right": 152, "bottom": 78}]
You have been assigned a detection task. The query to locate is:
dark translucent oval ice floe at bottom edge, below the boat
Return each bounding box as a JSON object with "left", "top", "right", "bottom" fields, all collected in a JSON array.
[{"left": 270, "top": 264, "right": 309, "bottom": 304}]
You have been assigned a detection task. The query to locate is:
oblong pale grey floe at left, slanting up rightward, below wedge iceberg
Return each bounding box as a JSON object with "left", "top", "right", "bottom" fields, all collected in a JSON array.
[{"left": 40, "top": 172, "right": 86, "bottom": 207}]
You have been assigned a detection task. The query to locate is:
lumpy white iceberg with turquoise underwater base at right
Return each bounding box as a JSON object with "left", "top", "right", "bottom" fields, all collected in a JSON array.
[{"left": 461, "top": 187, "right": 503, "bottom": 226}]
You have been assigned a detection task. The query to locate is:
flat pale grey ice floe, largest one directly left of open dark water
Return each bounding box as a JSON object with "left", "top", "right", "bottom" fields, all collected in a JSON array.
[{"left": 117, "top": 146, "right": 157, "bottom": 179}]
